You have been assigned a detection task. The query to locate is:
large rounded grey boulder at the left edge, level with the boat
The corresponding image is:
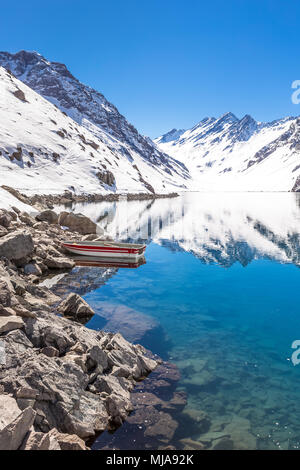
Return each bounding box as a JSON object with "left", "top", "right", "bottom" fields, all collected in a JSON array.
[{"left": 0, "top": 231, "right": 34, "bottom": 261}]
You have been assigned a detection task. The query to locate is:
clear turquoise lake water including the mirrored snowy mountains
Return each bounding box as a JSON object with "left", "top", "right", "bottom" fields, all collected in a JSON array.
[{"left": 68, "top": 194, "right": 300, "bottom": 449}]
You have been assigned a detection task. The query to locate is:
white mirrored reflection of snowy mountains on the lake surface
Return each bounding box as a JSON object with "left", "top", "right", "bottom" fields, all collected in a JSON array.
[{"left": 62, "top": 193, "right": 300, "bottom": 267}]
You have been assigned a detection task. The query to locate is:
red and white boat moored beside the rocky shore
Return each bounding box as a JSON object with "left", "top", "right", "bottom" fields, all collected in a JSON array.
[{"left": 62, "top": 241, "right": 146, "bottom": 260}]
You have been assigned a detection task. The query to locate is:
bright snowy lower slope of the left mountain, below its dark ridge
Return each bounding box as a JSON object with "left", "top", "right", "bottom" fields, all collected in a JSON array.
[{"left": 0, "top": 63, "right": 189, "bottom": 195}]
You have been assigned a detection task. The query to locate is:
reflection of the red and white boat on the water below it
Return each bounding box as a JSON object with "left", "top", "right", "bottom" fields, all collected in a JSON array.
[{"left": 72, "top": 255, "right": 146, "bottom": 269}]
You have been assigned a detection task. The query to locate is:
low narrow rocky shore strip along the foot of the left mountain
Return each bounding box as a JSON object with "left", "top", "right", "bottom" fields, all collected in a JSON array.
[{"left": 1, "top": 185, "right": 178, "bottom": 210}]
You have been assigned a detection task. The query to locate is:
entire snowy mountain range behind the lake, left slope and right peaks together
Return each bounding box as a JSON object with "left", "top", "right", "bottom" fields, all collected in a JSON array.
[{"left": 0, "top": 51, "right": 300, "bottom": 193}]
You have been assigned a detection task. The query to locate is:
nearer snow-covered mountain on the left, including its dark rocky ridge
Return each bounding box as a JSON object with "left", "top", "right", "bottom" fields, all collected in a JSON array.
[{"left": 0, "top": 51, "right": 189, "bottom": 193}]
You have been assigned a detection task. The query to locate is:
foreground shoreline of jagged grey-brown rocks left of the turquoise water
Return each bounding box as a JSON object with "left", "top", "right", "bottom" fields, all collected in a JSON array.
[{"left": 0, "top": 205, "right": 160, "bottom": 450}]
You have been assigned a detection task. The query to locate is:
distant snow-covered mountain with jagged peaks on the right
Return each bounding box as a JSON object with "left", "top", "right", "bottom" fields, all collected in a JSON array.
[{"left": 155, "top": 113, "right": 300, "bottom": 191}]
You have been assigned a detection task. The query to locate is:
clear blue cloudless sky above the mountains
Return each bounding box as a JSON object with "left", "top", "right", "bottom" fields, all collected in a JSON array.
[{"left": 0, "top": 0, "right": 300, "bottom": 137}]
